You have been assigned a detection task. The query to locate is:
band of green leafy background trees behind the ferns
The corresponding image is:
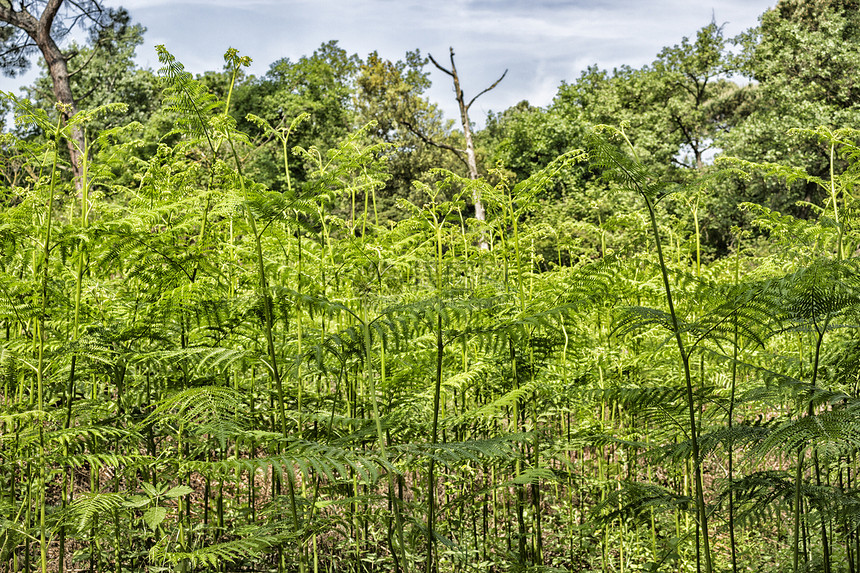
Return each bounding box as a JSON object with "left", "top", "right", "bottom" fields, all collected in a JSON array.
[{"left": 3, "top": 0, "right": 860, "bottom": 262}]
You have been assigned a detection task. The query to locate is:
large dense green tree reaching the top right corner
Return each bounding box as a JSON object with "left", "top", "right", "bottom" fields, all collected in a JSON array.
[{"left": 722, "top": 0, "right": 860, "bottom": 216}]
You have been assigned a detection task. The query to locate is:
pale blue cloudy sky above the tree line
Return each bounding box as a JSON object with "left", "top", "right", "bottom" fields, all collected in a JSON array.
[{"left": 0, "top": 0, "right": 776, "bottom": 127}]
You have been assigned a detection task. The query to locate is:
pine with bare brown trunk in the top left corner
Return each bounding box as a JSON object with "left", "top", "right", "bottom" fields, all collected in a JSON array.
[{"left": 0, "top": 0, "right": 128, "bottom": 183}]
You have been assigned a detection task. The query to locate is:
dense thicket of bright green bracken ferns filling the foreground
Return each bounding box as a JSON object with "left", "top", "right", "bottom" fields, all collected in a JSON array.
[{"left": 0, "top": 45, "right": 860, "bottom": 573}]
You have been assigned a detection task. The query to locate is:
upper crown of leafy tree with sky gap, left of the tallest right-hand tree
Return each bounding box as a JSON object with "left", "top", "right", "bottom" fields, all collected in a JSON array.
[{"left": 552, "top": 22, "right": 739, "bottom": 177}]
